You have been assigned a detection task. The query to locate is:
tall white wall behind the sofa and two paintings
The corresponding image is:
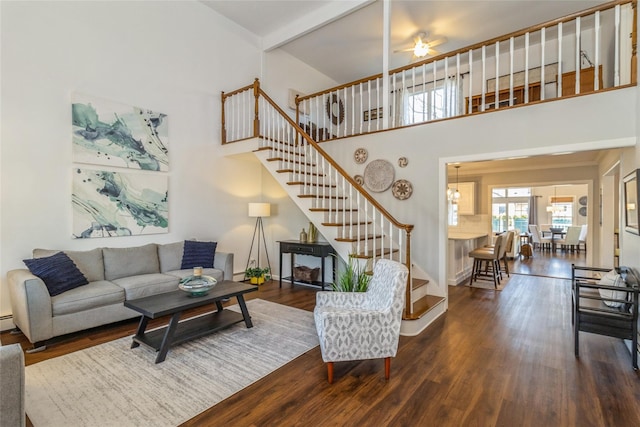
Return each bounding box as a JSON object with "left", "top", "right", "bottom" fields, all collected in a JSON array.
[{"left": 0, "top": 1, "right": 335, "bottom": 329}]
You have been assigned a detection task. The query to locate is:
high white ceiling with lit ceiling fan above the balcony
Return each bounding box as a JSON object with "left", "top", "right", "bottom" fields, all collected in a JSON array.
[{"left": 202, "top": 0, "right": 607, "bottom": 84}]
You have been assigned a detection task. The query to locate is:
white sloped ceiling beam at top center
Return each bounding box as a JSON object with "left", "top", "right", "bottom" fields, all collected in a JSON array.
[{"left": 262, "top": 0, "right": 375, "bottom": 52}]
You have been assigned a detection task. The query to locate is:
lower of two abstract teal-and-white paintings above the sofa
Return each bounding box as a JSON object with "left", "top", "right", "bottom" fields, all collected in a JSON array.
[{"left": 72, "top": 168, "right": 169, "bottom": 239}]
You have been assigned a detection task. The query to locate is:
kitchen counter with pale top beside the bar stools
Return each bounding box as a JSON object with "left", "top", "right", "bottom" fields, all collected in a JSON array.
[{"left": 447, "top": 231, "right": 489, "bottom": 286}]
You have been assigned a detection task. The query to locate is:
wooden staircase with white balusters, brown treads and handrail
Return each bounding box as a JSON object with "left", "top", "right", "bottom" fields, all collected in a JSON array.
[{"left": 222, "top": 79, "right": 446, "bottom": 335}]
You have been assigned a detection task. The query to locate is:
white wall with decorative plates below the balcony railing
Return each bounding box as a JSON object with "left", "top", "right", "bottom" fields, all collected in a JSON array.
[{"left": 323, "top": 88, "right": 637, "bottom": 300}]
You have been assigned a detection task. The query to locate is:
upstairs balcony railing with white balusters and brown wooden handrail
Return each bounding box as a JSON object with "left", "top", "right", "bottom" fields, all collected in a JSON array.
[{"left": 296, "top": 0, "right": 637, "bottom": 141}]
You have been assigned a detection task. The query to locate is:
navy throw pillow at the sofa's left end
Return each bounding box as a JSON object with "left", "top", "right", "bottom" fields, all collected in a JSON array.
[{"left": 23, "top": 252, "right": 89, "bottom": 297}]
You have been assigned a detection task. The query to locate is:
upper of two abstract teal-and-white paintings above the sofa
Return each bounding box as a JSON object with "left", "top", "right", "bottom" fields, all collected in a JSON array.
[{"left": 71, "top": 94, "right": 169, "bottom": 171}]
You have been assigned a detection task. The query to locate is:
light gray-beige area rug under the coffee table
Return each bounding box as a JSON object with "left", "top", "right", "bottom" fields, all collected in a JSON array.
[{"left": 25, "top": 299, "right": 318, "bottom": 427}]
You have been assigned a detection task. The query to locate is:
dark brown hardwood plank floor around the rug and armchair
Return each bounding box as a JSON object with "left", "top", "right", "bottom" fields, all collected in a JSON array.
[{"left": 1, "top": 252, "right": 640, "bottom": 426}]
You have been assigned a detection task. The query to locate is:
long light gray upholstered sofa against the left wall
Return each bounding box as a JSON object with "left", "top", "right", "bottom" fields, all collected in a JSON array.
[{"left": 7, "top": 242, "right": 233, "bottom": 350}]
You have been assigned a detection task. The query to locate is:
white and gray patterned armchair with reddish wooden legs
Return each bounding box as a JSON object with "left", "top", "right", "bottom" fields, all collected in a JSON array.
[{"left": 313, "top": 259, "right": 408, "bottom": 384}]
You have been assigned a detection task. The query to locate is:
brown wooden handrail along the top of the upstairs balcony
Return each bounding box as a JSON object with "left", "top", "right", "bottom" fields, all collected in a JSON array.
[{"left": 296, "top": 0, "right": 637, "bottom": 103}]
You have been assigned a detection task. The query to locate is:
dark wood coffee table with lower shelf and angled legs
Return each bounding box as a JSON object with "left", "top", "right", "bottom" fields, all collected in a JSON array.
[{"left": 124, "top": 280, "right": 258, "bottom": 363}]
